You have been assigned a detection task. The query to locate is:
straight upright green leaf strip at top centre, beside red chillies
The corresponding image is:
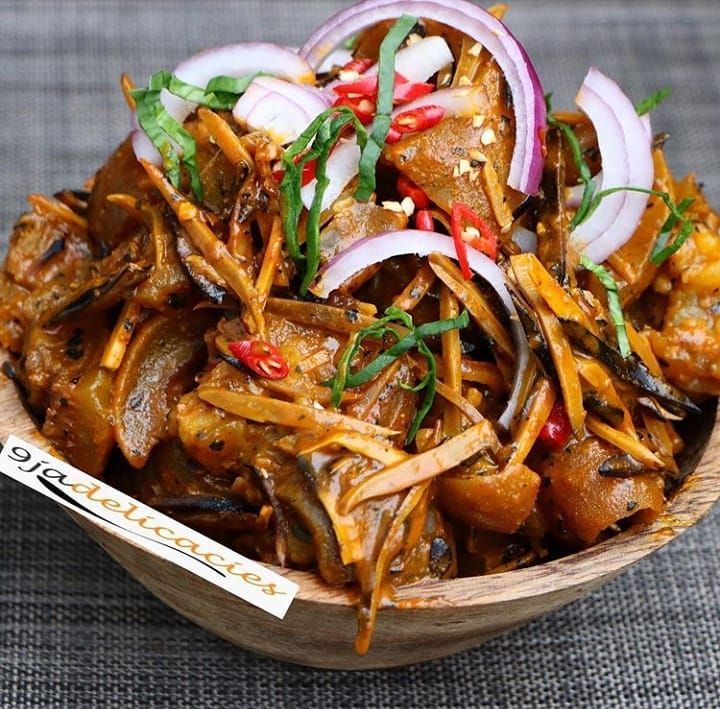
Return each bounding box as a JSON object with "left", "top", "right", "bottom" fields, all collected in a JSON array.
[{"left": 355, "top": 15, "right": 418, "bottom": 202}]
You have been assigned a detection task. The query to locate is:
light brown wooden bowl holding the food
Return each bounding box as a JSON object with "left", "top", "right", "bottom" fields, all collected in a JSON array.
[{"left": 0, "top": 360, "right": 720, "bottom": 670}]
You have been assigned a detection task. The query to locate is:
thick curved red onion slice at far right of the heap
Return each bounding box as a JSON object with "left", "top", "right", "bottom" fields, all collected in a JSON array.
[{"left": 572, "top": 68, "right": 654, "bottom": 263}]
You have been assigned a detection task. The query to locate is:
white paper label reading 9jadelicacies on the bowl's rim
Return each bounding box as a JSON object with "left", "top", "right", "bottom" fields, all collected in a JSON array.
[{"left": 0, "top": 436, "right": 298, "bottom": 619}]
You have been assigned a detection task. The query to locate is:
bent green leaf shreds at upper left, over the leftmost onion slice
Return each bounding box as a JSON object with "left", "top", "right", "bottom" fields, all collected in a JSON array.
[{"left": 130, "top": 71, "right": 259, "bottom": 201}]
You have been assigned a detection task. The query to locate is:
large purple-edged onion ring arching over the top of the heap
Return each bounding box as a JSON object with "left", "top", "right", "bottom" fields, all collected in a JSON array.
[{"left": 300, "top": 0, "right": 546, "bottom": 194}]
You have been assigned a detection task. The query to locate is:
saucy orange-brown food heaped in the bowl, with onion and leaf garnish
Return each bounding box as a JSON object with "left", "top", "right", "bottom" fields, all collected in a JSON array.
[{"left": 0, "top": 0, "right": 720, "bottom": 653}]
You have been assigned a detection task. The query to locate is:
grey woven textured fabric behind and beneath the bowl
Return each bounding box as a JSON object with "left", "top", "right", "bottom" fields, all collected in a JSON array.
[{"left": 0, "top": 0, "right": 720, "bottom": 708}]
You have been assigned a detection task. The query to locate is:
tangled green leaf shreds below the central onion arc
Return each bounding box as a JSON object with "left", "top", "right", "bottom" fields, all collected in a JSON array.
[{"left": 329, "top": 306, "right": 470, "bottom": 444}]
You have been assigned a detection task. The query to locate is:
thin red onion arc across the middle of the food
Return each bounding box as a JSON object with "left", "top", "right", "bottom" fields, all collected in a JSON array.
[{"left": 310, "top": 229, "right": 530, "bottom": 428}]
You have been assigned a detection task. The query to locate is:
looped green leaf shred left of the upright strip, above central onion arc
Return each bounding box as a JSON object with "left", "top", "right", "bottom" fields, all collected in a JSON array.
[{"left": 280, "top": 107, "right": 367, "bottom": 295}]
